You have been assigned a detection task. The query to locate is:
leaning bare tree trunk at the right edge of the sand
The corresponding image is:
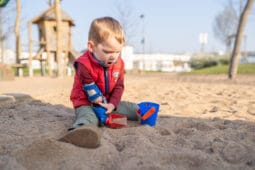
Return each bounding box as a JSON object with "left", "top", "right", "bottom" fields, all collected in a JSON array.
[{"left": 228, "top": 0, "right": 254, "bottom": 79}]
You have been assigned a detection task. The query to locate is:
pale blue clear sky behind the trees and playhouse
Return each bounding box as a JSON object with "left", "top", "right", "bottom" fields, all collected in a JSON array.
[{"left": 1, "top": 0, "right": 255, "bottom": 53}]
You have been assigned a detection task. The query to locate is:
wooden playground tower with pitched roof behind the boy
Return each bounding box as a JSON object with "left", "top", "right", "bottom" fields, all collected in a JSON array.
[{"left": 25, "top": 5, "right": 79, "bottom": 77}]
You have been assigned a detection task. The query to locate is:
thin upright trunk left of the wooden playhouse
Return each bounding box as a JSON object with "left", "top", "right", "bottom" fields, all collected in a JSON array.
[{"left": 15, "top": 0, "right": 21, "bottom": 75}]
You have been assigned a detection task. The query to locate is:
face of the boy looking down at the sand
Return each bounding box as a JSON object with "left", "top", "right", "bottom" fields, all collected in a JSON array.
[{"left": 88, "top": 36, "right": 123, "bottom": 67}]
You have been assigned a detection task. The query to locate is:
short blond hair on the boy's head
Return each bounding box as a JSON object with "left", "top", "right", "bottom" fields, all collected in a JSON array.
[{"left": 88, "top": 17, "right": 125, "bottom": 44}]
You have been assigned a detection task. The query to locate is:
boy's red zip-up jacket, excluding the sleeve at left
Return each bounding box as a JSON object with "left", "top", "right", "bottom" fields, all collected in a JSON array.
[{"left": 70, "top": 51, "right": 124, "bottom": 108}]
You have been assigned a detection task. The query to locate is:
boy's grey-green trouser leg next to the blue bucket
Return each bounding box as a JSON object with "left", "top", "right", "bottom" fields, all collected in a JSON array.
[{"left": 114, "top": 101, "right": 139, "bottom": 120}]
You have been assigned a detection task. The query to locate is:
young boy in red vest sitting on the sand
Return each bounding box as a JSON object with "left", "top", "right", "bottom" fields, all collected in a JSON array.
[{"left": 61, "top": 17, "right": 138, "bottom": 148}]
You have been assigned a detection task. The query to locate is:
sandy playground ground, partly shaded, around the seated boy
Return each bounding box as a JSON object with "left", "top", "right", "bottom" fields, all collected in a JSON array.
[{"left": 0, "top": 73, "right": 255, "bottom": 170}]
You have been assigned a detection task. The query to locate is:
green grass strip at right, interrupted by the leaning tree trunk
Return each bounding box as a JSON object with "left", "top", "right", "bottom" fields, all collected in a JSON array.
[{"left": 188, "top": 64, "right": 255, "bottom": 75}]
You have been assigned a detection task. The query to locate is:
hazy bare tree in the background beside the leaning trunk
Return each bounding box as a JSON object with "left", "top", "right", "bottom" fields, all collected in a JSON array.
[{"left": 213, "top": 1, "right": 239, "bottom": 54}]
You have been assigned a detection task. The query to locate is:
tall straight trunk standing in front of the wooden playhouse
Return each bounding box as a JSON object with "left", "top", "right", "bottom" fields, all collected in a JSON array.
[{"left": 55, "top": 0, "right": 64, "bottom": 77}]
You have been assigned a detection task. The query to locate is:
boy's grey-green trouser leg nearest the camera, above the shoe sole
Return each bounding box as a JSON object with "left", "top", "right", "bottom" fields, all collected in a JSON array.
[{"left": 69, "top": 106, "right": 99, "bottom": 130}]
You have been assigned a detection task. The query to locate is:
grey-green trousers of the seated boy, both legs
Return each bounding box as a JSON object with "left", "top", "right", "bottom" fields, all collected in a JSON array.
[{"left": 69, "top": 101, "right": 138, "bottom": 130}]
